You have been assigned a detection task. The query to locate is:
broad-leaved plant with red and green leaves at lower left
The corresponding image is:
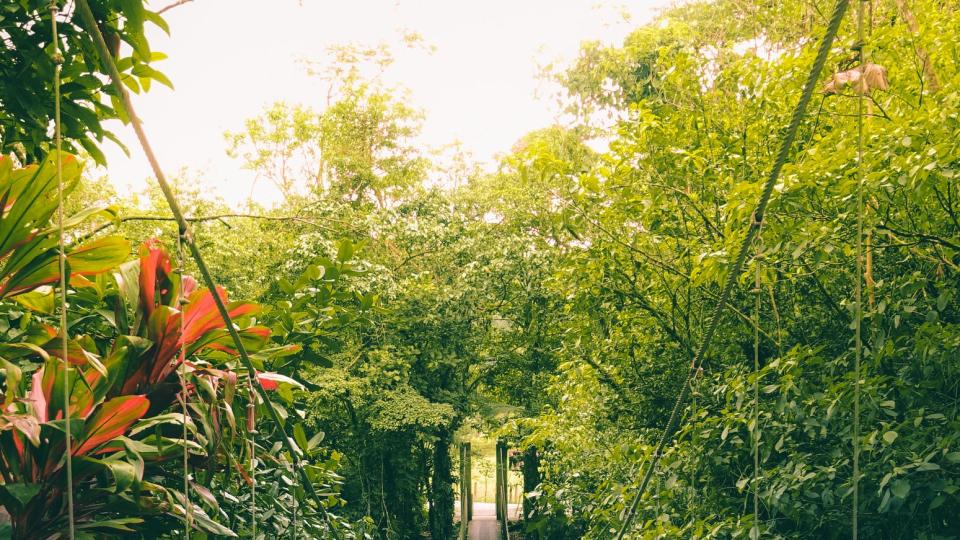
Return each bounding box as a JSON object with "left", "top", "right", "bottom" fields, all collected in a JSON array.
[{"left": 0, "top": 154, "right": 286, "bottom": 539}]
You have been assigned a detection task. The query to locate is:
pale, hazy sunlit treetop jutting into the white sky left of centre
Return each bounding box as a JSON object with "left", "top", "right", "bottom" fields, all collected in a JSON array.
[{"left": 226, "top": 36, "right": 428, "bottom": 208}]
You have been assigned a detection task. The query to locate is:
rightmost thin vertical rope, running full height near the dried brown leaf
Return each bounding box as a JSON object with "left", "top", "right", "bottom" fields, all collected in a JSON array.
[{"left": 851, "top": 0, "right": 867, "bottom": 540}]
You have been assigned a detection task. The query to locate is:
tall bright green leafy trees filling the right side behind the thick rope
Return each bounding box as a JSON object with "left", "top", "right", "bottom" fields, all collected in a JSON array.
[{"left": 510, "top": 2, "right": 958, "bottom": 538}]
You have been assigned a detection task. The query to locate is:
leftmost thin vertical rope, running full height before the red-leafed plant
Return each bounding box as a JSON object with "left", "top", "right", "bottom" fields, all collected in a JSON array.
[{"left": 50, "top": 0, "right": 76, "bottom": 540}]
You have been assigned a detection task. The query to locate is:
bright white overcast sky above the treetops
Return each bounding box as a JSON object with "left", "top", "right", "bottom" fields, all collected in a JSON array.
[{"left": 104, "top": 0, "right": 669, "bottom": 205}]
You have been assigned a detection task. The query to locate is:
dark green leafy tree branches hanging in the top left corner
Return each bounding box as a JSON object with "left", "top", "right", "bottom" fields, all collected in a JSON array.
[{"left": 0, "top": 0, "right": 172, "bottom": 164}]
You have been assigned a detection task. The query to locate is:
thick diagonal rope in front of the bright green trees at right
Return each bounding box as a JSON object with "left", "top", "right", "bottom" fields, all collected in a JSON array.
[{"left": 616, "top": 0, "right": 850, "bottom": 540}]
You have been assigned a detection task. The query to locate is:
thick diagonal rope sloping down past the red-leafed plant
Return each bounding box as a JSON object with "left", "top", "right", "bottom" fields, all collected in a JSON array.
[{"left": 76, "top": 0, "right": 343, "bottom": 538}]
